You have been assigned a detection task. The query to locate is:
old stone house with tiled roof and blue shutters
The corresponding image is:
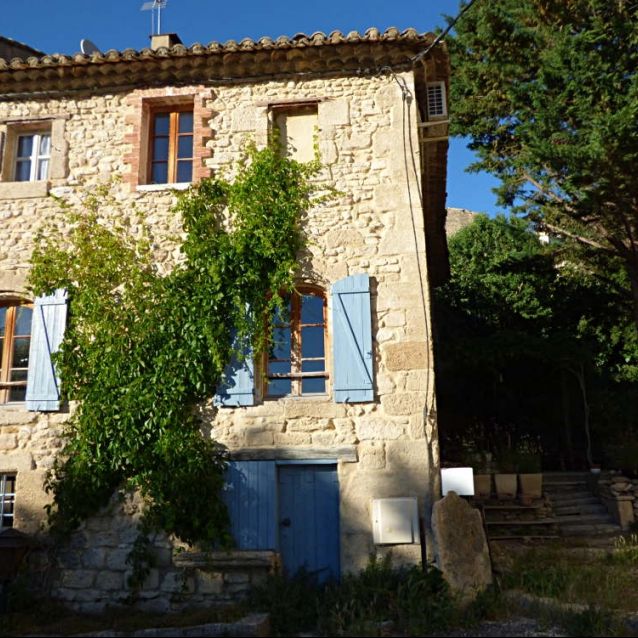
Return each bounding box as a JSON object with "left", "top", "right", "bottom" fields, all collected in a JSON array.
[{"left": 0, "top": 29, "right": 449, "bottom": 609}]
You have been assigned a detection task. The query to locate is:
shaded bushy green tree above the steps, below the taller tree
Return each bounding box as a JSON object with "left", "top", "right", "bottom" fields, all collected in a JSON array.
[{"left": 436, "top": 216, "right": 638, "bottom": 467}]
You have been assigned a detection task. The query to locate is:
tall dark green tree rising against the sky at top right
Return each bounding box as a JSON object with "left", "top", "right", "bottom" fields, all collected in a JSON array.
[{"left": 449, "top": 0, "right": 638, "bottom": 326}]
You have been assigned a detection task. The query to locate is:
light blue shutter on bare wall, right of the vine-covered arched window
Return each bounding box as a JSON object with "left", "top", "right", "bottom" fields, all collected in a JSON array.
[{"left": 332, "top": 274, "right": 374, "bottom": 403}]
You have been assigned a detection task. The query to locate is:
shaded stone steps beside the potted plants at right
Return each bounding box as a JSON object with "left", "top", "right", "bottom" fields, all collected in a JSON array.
[{"left": 543, "top": 472, "right": 622, "bottom": 538}]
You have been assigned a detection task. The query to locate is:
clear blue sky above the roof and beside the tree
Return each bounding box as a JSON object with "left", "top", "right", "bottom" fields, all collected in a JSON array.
[{"left": 0, "top": 0, "right": 504, "bottom": 213}]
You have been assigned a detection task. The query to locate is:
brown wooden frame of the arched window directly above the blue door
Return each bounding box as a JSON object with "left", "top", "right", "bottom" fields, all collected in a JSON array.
[{"left": 263, "top": 285, "right": 330, "bottom": 399}]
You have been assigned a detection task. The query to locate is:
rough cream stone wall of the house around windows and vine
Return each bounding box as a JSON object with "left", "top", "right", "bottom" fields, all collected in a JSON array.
[{"left": 0, "top": 27, "right": 447, "bottom": 609}]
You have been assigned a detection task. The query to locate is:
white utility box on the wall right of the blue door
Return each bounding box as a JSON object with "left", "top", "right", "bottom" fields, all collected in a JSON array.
[{"left": 372, "top": 496, "right": 421, "bottom": 545}]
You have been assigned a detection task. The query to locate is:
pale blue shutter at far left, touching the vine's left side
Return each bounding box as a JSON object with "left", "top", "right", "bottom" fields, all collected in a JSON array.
[{"left": 26, "top": 290, "right": 67, "bottom": 412}]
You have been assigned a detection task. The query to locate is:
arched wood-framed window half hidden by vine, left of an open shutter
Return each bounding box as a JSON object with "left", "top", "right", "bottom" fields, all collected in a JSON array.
[{"left": 266, "top": 288, "right": 328, "bottom": 397}]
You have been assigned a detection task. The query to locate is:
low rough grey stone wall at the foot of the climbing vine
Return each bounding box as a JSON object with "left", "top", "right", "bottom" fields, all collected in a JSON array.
[{"left": 43, "top": 496, "right": 277, "bottom": 613}]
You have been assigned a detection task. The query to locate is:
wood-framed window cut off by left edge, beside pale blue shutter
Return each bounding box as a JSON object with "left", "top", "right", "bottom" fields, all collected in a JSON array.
[{"left": 0, "top": 301, "right": 33, "bottom": 403}]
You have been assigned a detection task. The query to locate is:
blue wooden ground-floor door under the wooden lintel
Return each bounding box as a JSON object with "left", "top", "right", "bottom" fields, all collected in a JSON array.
[{"left": 278, "top": 464, "right": 339, "bottom": 582}]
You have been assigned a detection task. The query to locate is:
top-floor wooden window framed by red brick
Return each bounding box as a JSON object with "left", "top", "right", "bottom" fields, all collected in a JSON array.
[{"left": 148, "top": 105, "right": 193, "bottom": 184}]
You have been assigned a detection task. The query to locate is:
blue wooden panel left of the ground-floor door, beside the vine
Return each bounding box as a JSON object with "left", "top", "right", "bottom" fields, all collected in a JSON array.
[{"left": 223, "top": 461, "right": 277, "bottom": 549}]
